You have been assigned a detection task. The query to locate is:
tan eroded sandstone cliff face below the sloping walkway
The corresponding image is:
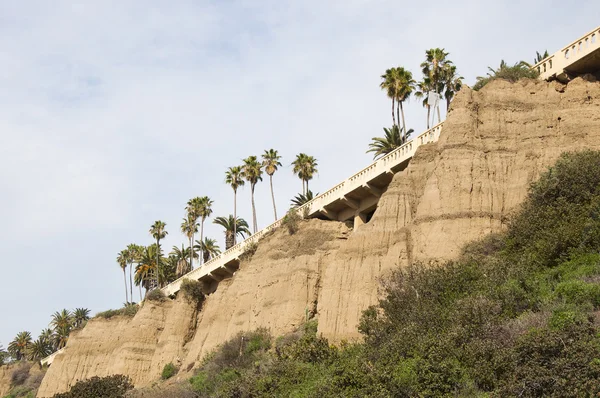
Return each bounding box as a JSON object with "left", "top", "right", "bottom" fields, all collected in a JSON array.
[{"left": 38, "top": 79, "right": 600, "bottom": 397}]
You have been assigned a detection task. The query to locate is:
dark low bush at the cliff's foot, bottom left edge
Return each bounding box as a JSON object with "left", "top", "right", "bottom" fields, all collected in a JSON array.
[{"left": 54, "top": 375, "right": 133, "bottom": 398}]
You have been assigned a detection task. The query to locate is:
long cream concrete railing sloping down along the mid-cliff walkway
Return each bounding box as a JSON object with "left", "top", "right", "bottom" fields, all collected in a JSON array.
[{"left": 162, "top": 123, "right": 443, "bottom": 296}]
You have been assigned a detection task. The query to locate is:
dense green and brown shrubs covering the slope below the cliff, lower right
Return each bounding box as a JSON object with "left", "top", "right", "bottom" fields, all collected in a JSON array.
[{"left": 179, "top": 152, "right": 600, "bottom": 397}]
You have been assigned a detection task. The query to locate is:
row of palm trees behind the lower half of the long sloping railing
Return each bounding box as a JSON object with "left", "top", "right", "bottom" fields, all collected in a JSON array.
[{"left": 117, "top": 149, "right": 318, "bottom": 303}]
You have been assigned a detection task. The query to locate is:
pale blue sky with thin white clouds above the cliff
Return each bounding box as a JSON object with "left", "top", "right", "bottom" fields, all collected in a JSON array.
[{"left": 0, "top": 0, "right": 600, "bottom": 347}]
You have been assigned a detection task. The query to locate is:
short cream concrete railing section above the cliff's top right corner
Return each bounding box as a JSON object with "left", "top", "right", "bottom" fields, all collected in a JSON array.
[{"left": 532, "top": 27, "right": 600, "bottom": 79}]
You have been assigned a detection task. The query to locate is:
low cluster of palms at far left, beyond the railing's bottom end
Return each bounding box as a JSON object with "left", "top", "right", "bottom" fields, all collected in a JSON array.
[{"left": 0, "top": 308, "right": 90, "bottom": 365}]
